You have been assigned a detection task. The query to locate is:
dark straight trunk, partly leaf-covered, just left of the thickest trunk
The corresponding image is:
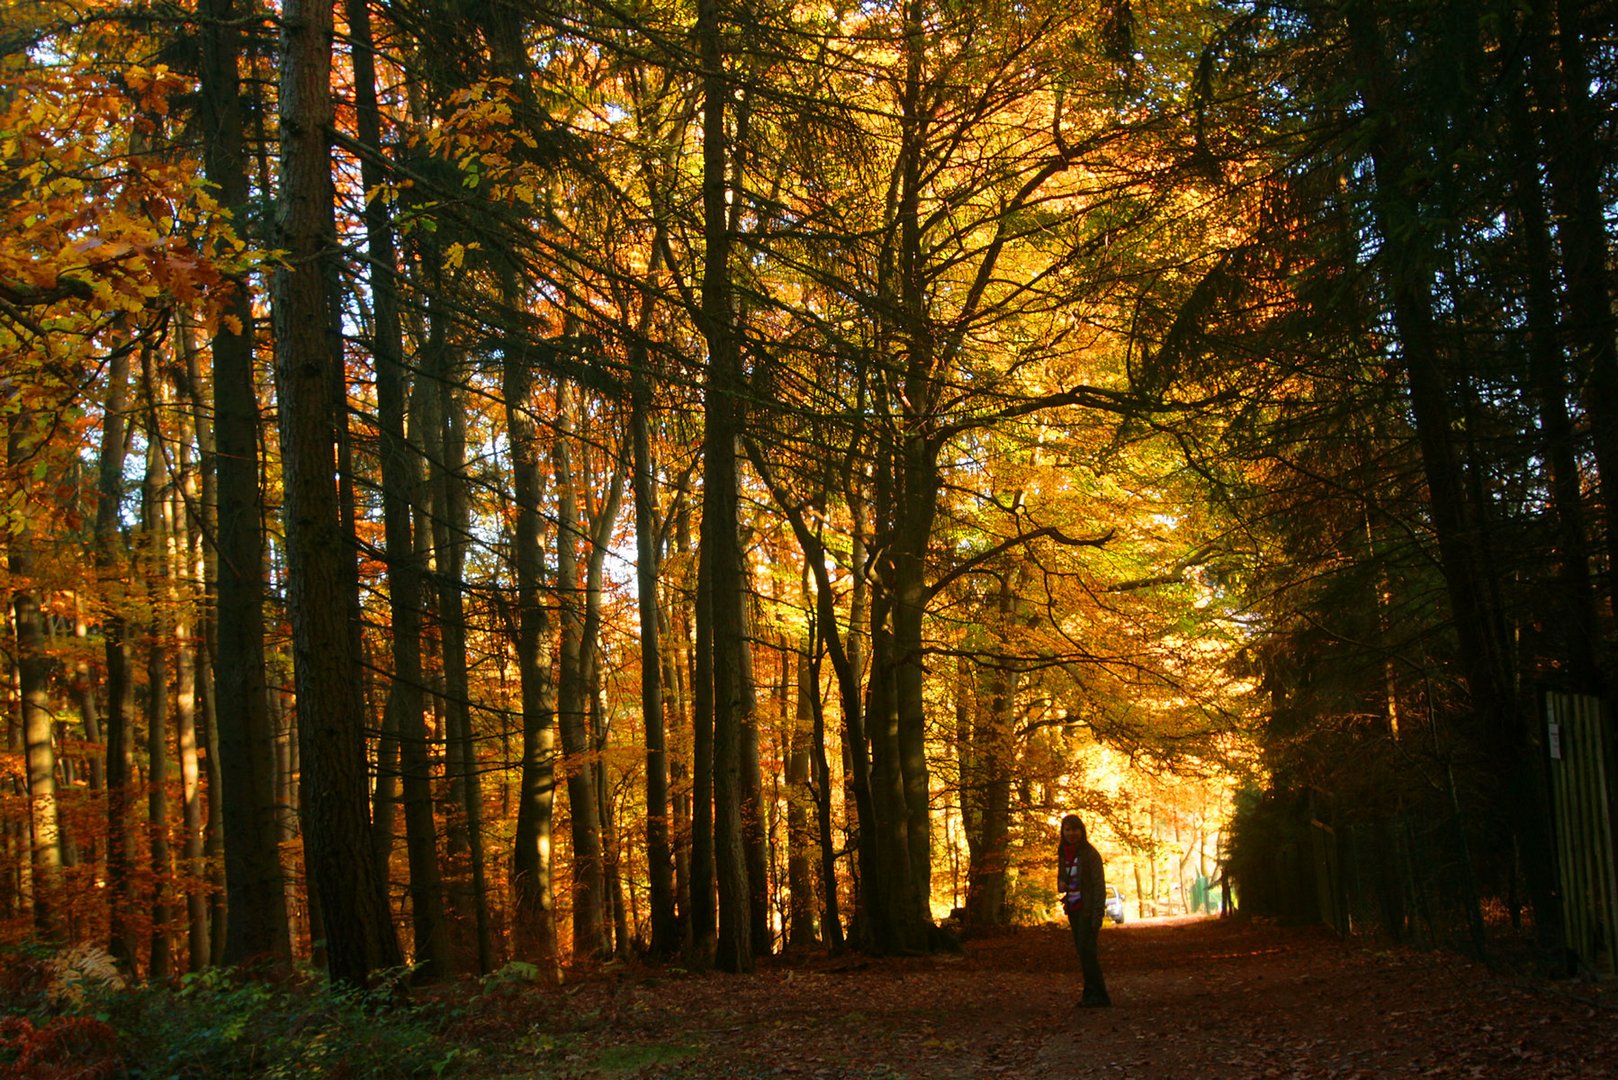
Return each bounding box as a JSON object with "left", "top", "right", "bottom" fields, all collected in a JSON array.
[{"left": 201, "top": 0, "right": 291, "bottom": 963}]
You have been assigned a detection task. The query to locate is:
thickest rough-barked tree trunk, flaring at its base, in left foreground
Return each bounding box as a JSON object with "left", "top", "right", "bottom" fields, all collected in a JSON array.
[{"left": 273, "top": 0, "right": 400, "bottom": 986}]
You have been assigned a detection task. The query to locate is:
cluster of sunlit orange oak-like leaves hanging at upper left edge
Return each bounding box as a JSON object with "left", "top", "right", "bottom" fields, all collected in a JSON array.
[{"left": 0, "top": 58, "right": 256, "bottom": 368}]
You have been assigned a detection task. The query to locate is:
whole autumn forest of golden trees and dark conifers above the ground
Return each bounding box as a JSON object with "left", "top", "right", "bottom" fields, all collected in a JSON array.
[{"left": 0, "top": 0, "right": 1618, "bottom": 1003}]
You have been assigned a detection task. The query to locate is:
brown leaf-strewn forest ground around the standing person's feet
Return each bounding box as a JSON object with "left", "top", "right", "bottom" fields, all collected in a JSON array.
[{"left": 460, "top": 918, "right": 1618, "bottom": 1080}]
